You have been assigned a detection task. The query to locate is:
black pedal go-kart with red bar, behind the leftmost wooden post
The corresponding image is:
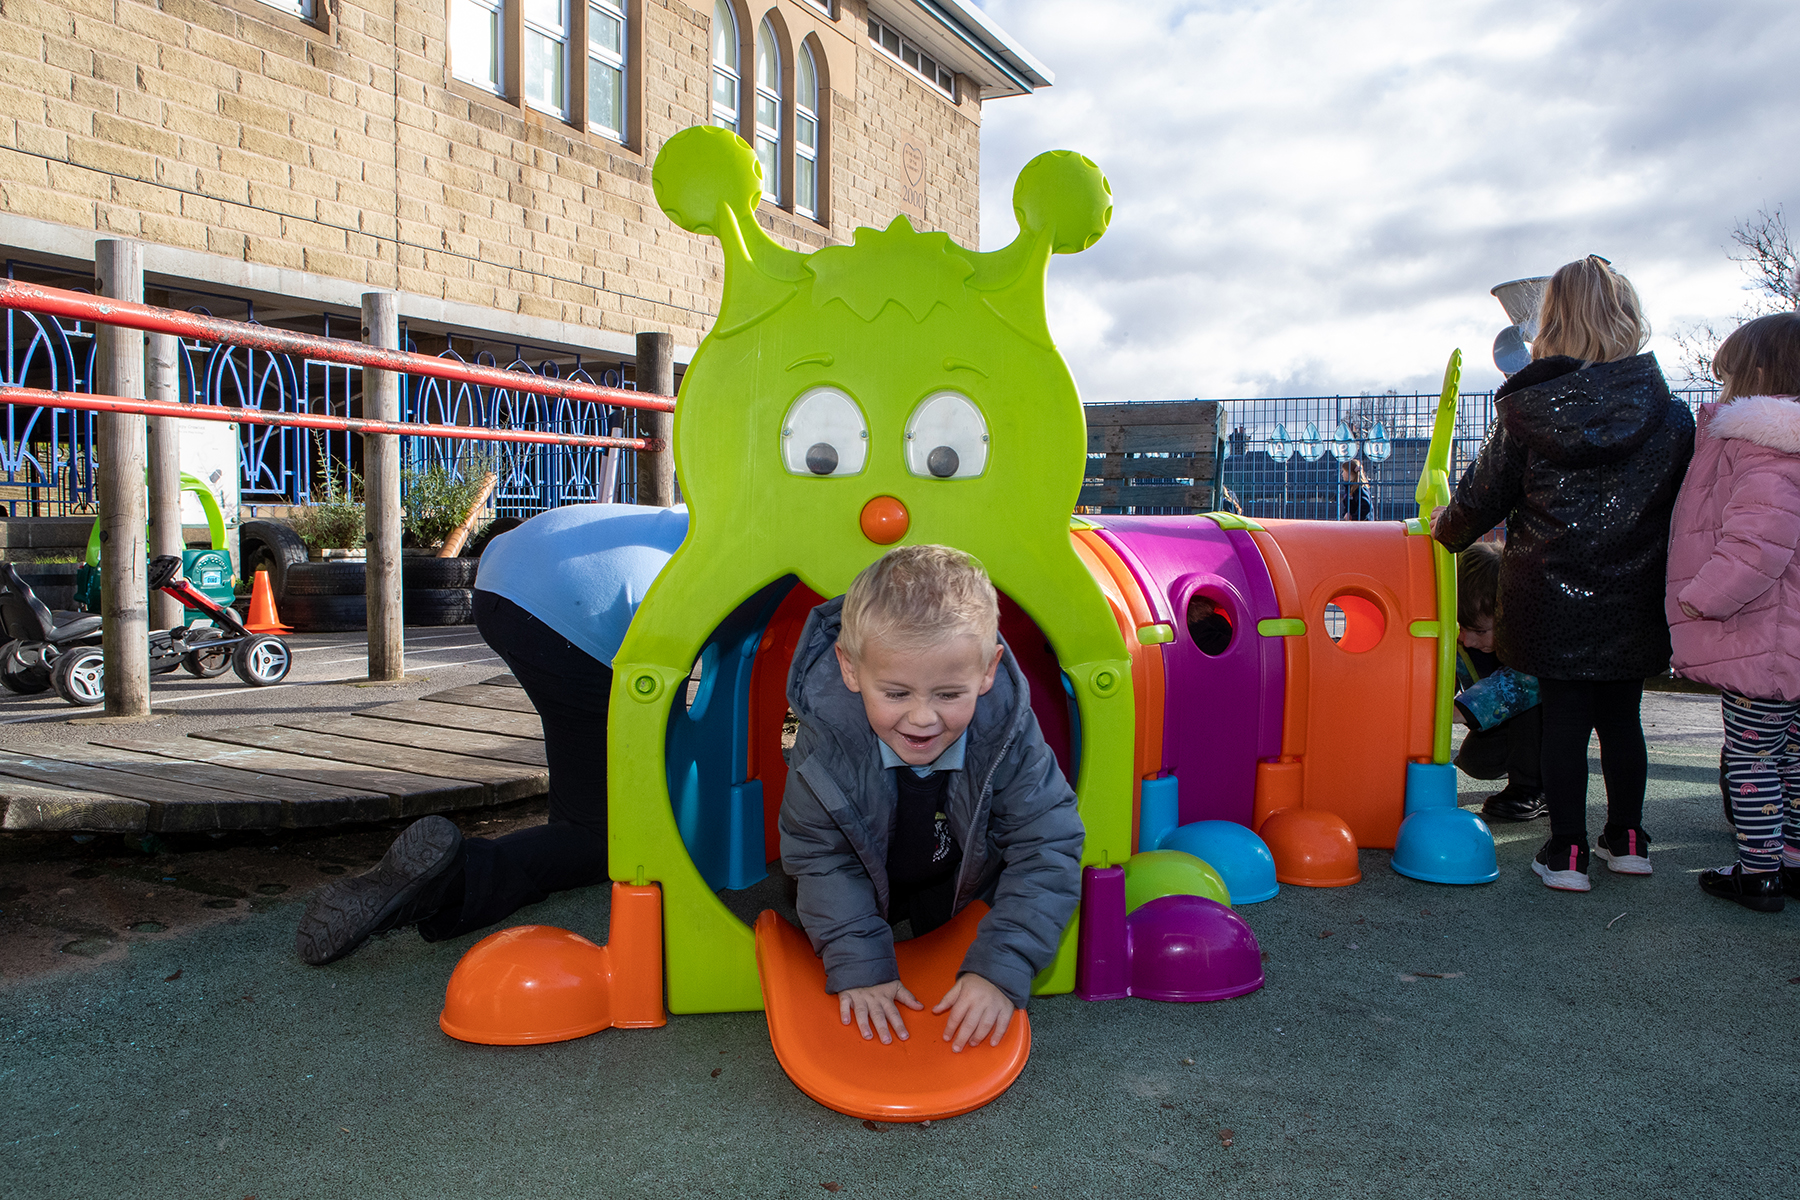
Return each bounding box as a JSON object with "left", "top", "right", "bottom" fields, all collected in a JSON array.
[{"left": 14, "top": 554, "right": 293, "bottom": 705}]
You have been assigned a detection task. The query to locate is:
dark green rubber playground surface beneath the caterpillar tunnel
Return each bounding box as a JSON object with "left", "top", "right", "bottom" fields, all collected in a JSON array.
[{"left": 0, "top": 696, "right": 1800, "bottom": 1200}]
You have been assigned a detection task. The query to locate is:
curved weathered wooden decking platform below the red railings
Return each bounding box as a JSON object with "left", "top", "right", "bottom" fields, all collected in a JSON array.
[{"left": 0, "top": 675, "right": 547, "bottom": 833}]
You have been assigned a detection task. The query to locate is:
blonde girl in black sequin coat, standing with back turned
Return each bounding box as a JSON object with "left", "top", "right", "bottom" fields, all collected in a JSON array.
[{"left": 1433, "top": 255, "right": 1694, "bottom": 891}]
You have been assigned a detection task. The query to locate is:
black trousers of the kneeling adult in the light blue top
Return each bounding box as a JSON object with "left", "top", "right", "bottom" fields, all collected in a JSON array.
[{"left": 419, "top": 592, "right": 612, "bottom": 941}]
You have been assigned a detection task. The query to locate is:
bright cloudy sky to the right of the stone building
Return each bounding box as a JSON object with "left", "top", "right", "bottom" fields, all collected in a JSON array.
[{"left": 981, "top": 0, "right": 1800, "bottom": 399}]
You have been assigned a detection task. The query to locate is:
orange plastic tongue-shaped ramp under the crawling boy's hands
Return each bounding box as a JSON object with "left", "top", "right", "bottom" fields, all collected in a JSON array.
[{"left": 756, "top": 901, "right": 1031, "bottom": 1121}]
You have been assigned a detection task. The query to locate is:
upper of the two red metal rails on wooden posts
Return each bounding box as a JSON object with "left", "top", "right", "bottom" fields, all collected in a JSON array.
[{"left": 0, "top": 279, "right": 675, "bottom": 417}]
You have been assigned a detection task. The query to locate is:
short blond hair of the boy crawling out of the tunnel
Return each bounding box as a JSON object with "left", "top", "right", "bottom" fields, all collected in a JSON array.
[{"left": 837, "top": 545, "right": 1001, "bottom": 660}]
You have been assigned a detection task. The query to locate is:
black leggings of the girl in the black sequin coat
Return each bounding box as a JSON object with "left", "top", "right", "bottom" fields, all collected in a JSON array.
[{"left": 1537, "top": 678, "right": 1651, "bottom": 846}]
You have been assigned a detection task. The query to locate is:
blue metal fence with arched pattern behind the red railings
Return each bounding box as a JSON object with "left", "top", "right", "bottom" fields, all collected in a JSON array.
[{"left": 0, "top": 261, "right": 639, "bottom": 516}]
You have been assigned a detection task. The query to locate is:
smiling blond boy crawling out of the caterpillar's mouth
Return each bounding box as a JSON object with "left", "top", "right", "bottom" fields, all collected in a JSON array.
[{"left": 781, "top": 545, "right": 1084, "bottom": 1051}]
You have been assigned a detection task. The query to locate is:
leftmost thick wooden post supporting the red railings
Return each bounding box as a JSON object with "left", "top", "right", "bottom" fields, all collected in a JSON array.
[{"left": 94, "top": 237, "right": 149, "bottom": 716}]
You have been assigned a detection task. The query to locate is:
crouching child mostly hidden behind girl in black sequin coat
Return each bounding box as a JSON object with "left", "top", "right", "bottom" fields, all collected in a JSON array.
[{"left": 1456, "top": 542, "right": 1550, "bottom": 820}]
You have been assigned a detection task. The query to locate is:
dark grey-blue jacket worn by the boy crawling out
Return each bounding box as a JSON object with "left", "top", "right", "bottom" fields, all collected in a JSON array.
[{"left": 781, "top": 597, "right": 1084, "bottom": 1007}]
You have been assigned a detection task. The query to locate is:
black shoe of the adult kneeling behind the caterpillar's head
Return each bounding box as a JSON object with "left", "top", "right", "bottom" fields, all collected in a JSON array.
[{"left": 293, "top": 817, "right": 463, "bottom": 966}]
